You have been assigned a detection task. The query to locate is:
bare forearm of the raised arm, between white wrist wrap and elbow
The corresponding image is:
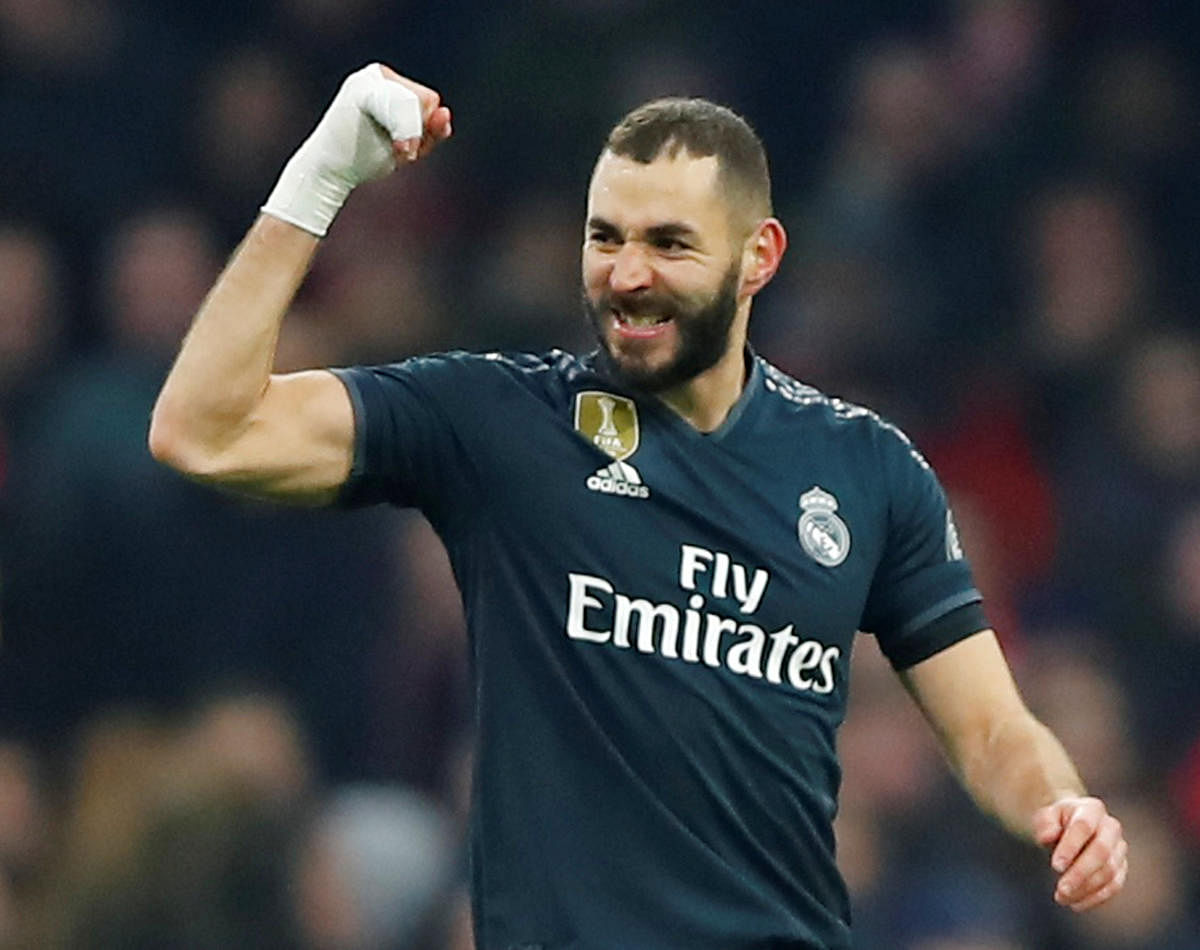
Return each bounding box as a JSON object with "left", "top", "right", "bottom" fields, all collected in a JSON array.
[{"left": 150, "top": 215, "right": 318, "bottom": 468}]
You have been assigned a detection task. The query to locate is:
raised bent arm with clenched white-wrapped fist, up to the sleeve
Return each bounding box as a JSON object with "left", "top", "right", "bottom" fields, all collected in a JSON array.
[{"left": 150, "top": 64, "right": 450, "bottom": 504}]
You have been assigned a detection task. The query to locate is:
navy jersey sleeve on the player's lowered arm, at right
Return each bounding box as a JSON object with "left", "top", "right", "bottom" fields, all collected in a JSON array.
[{"left": 862, "top": 427, "right": 988, "bottom": 669}]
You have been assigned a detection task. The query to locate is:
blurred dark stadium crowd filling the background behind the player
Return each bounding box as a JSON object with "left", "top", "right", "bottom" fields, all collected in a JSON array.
[{"left": 0, "top": 0, "right": 1200, "bottom": 950}]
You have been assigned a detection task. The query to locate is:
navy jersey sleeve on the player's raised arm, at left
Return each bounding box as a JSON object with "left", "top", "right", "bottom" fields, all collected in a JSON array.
[{"left": 332, "top": 355, "right": 482, "bottom": 521}]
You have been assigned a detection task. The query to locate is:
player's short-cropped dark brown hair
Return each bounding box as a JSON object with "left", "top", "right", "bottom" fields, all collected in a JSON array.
[{"left": 605, "top": 97, "right": 772, "bottom": 221}]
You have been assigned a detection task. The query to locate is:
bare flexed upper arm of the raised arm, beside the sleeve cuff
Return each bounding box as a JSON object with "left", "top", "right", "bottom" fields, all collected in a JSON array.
[{"left": 212, "top": 369, "right": 355, "bottom": 505}]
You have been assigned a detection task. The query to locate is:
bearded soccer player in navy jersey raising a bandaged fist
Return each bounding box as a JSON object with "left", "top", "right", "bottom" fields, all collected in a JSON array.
[{"left": 150, "top": 65, "right": 1127, "bottom": 950}]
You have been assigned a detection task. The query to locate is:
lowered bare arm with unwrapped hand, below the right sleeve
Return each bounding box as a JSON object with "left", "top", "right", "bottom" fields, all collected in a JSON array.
[{"left": 901, "top": 630, "right": 1128, "bottom": 910}]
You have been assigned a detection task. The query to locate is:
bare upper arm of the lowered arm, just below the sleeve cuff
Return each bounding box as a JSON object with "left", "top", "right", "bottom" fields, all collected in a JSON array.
[{"left": 900, "top": 630, "right": 1028, "bottom": 765}]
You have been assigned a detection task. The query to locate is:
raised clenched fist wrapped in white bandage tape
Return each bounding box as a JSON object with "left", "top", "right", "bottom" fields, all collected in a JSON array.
[{"left": 262, "top": 62, "right": 450, "bottom": 238}]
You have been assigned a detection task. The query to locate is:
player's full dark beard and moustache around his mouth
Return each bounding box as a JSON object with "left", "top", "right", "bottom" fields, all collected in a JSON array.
[{"left": 583, "top": 261, "right": 739, "bottom": 392}]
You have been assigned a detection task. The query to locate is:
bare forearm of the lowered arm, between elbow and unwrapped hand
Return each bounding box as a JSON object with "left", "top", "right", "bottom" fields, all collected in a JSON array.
[{"left": 953, "top": 711, "right": 1086, "bottom": 838}]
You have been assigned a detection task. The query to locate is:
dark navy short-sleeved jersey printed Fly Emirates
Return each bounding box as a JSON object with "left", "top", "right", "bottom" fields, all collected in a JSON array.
[{"left": 336, "top": 351, "right": 986, "bottom": 950}]
